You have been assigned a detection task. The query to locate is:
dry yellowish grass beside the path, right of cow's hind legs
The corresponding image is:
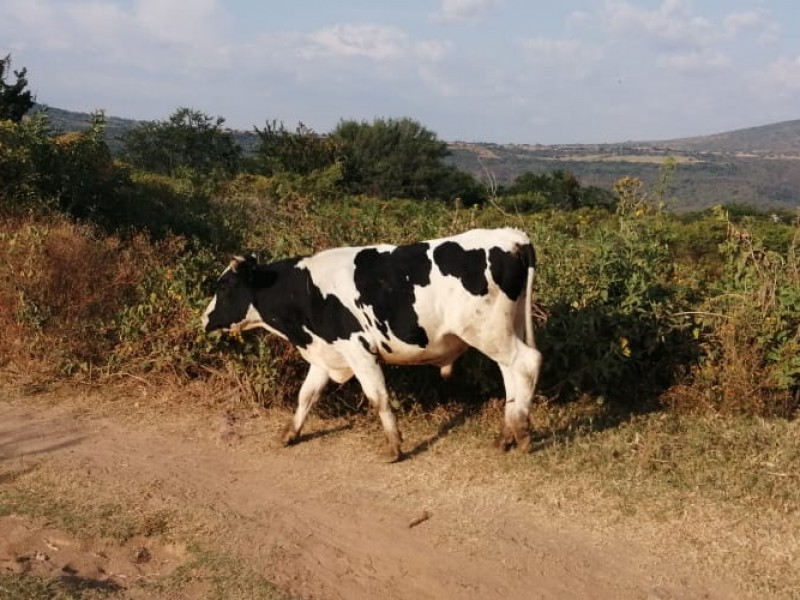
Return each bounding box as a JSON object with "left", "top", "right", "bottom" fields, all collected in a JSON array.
[{"left": 386, "top": 402, "right": 800, "bottom": 600}]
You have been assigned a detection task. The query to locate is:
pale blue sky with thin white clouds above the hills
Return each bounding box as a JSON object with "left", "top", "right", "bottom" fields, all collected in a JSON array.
[{"left": 0, "top": 0, "right": 800, "bottom": 144}]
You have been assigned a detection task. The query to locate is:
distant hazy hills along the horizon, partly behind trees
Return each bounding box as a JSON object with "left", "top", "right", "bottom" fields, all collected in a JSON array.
[{"left": 28, "top": 108, "right": 800, "bottom": 211}]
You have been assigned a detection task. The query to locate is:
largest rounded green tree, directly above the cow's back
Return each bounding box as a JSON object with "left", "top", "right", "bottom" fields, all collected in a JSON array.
[{"left": 331, "top": 118, "right": 457, "bottom": 200}]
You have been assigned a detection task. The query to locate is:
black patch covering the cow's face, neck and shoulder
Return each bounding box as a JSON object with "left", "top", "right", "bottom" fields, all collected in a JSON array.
[{"left": 208, "top": 258, "right": 362, "bottom": 348}]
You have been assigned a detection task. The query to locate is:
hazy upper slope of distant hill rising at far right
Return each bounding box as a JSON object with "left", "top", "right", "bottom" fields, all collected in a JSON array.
[{"left": 649, "top": 120, "right": 800, "bottom": 156}]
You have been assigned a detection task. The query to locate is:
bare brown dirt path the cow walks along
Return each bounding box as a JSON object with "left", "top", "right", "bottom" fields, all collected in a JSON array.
[{"left": 0, "top": 398, "right": 742, "bottom": 600}]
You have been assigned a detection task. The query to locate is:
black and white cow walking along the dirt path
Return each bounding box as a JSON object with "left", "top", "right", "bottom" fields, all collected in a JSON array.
[{"left": 202, "top": 228, "right": 542, "bottom": 462}]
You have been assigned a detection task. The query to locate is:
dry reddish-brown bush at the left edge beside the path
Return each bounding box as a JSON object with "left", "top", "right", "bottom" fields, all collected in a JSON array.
[{"left": 0, "top": 217, "right": 153, "bottom": 372}]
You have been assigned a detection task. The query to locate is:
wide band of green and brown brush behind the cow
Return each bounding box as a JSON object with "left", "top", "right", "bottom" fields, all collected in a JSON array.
[{"left": 0, "top": 168, "right": 800, "bottom": 422}]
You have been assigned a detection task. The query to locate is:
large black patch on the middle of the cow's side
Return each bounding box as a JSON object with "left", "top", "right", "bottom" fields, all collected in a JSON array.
[{"left": 355, "top": 242, "right": 432, "bottom": 348}]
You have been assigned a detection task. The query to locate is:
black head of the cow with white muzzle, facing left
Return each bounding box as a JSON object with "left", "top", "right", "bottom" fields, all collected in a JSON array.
[{"left": 202, "top": 255, "right": 256, "bottom": 332}]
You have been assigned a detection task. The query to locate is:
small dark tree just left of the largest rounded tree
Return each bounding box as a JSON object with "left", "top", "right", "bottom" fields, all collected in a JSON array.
[{"left": 255, "top": 120, "right": 340, "bottom": 175}]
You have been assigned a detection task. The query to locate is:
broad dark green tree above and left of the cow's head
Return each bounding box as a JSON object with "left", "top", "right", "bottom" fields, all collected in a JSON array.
[{"left": 122, "top": 107, "right": 242, "bottom": 178}]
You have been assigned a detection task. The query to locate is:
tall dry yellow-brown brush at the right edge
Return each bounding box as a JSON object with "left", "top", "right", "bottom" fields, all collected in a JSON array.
[{"left": 680, "top": 210, "right": 800, "bottom": 416}]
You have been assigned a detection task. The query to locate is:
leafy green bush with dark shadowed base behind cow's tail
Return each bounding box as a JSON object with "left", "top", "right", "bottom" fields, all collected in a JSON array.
[{"left": 536, "top": 195, "right": 696, "bottom": 410}]
